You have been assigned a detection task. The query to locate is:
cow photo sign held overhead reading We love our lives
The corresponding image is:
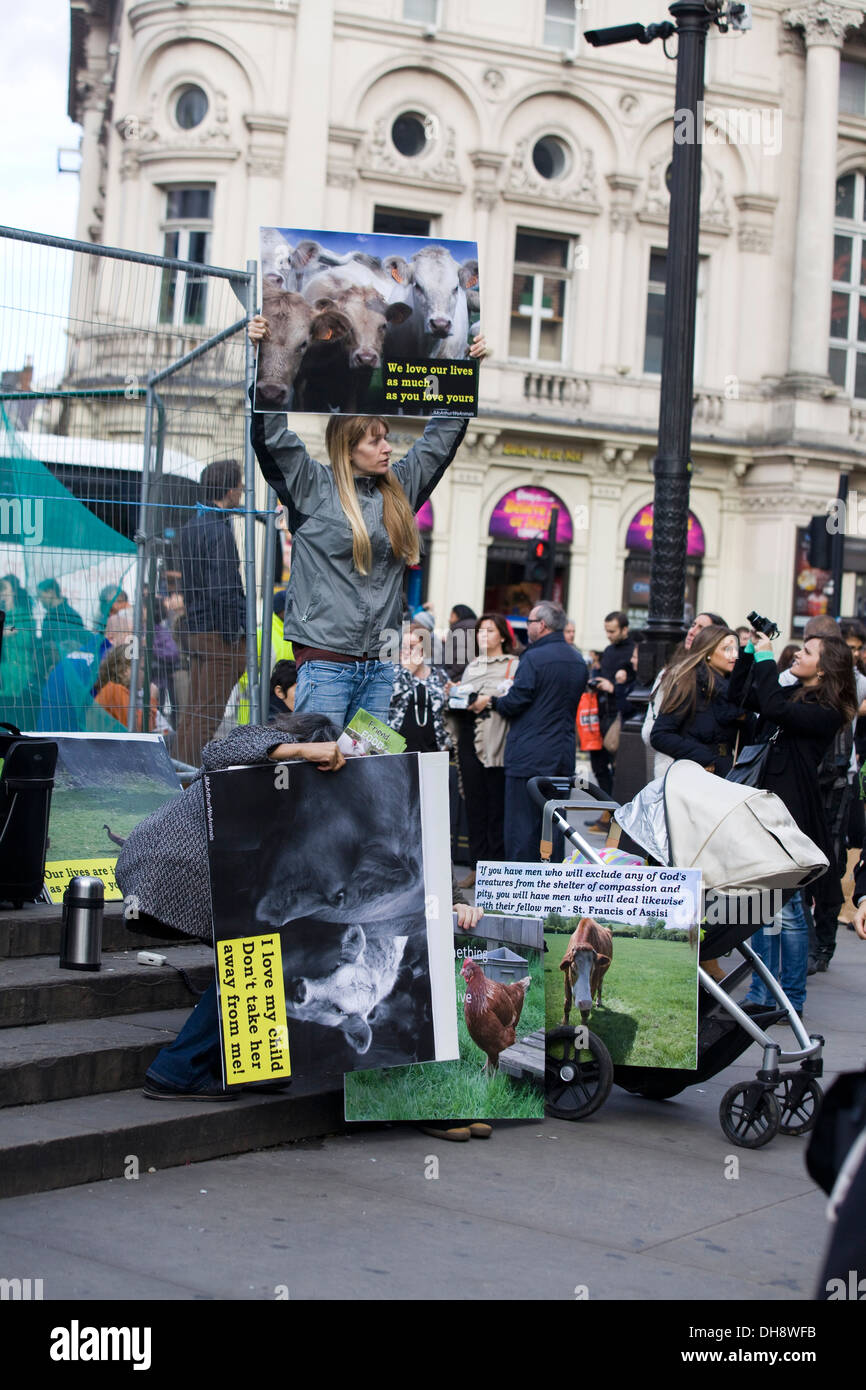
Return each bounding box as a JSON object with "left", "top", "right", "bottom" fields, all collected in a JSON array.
[{"left": 254, "top": 227, "right": 480, "bottom": 416}]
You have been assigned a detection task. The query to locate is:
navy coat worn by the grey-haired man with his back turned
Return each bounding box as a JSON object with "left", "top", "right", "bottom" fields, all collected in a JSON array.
[{"left": 496, "top": 632, "right": 587, "bottom": 777}]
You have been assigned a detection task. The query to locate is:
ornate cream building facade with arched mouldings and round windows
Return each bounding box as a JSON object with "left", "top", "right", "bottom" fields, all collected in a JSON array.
[{"left": 70, "top": 0, "right": 866, "bottom": 645}]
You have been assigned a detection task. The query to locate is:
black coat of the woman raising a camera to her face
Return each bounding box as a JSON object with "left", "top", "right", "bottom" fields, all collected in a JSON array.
[{"left": 728, "top": 652, "right": 844, "bottom": 905}]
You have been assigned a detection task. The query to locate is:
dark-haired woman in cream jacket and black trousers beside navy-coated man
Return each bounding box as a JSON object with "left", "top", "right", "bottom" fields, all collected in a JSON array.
[{"left": 450, "top": 613, "right": 517, "bottom": 888}]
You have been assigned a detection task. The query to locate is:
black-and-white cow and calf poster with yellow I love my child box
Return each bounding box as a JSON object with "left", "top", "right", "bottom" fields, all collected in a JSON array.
[{"left": 204, "top": 753, "right": 457, "bottom": 1094}]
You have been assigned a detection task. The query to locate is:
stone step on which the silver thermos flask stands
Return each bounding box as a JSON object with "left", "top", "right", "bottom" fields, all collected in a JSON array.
[{"left": 0, "top": 942, "right": 214, "bottom": 1029}]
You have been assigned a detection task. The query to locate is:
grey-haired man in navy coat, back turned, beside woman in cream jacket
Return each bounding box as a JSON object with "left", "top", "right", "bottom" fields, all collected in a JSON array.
[{"left": 475, "top": 599, "right": 587, "bottom": 860}]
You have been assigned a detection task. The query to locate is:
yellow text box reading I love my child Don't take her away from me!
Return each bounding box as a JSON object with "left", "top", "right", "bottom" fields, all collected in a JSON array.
[{"left": 217, "top": 933, "right": 292, "bottom": 1086}]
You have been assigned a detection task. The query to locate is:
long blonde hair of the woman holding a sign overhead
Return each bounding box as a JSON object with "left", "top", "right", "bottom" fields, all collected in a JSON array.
[{"left": 325, "top": 416, "right": 421, "bottom": 574}]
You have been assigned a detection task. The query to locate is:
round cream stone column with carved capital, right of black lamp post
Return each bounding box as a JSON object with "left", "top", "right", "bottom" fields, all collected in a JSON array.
[{"left": 783, "top": 0, "right": 866, "bottom": 392}]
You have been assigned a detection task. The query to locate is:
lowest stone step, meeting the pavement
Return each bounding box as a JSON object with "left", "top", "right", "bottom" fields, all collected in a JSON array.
[{"left": 0, "top": 1088, "right": 346, "bottom": 1197}]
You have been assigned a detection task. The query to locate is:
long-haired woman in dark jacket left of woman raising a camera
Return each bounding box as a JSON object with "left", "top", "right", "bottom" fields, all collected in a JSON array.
[{"left": 649, "top": 624, "right": 741, "bottom": 777}]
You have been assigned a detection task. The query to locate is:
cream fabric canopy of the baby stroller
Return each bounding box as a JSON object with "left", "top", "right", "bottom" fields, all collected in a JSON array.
[{"left": 614, "top": 759, "right": 827, "bottom": 892}]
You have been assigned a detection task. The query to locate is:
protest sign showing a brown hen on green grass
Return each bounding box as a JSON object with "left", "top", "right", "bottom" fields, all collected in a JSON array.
[{"left": 343, "top": 915, "right": 545, "bottom": 1120}]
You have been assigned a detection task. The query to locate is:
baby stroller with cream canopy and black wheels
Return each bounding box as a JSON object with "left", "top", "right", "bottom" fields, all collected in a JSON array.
[{"left": 530, "top": 762, "right": 827, "bottom": 1148}]
